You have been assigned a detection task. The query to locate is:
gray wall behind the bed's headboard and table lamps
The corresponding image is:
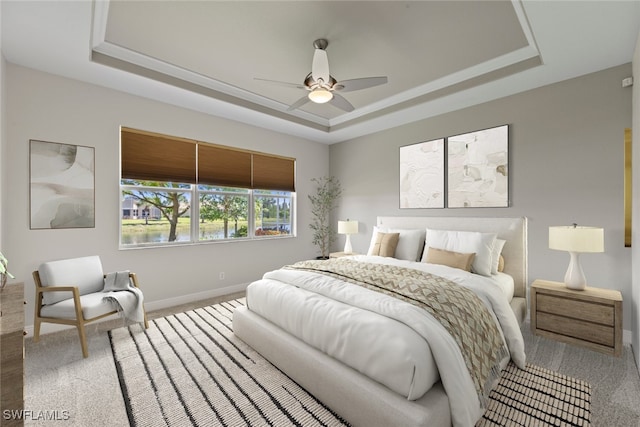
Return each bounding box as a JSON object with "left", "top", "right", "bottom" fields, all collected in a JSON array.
[{"left": 330, "top": 64, "right": 635, "bottom": 337}]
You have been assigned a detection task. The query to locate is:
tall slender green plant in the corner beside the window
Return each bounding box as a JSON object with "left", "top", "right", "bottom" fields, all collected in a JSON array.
[{"left": 309, "top": 176, "right": 342, "bottom": 259}]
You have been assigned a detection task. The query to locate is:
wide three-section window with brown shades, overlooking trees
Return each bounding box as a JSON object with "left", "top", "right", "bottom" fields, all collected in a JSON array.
[{"left": 120, "top": 128, "right": 295, "bottom": 247}]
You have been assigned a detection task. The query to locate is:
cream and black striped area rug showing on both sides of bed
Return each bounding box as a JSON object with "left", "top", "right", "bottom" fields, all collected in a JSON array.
[{"left": 109, "top": 299, "right": 591, "bottom": 427}]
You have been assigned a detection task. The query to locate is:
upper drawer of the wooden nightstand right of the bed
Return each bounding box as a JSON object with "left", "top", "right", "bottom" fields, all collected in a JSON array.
[{"left": 536, "top": 293, "right": 615, "bottom": 326}]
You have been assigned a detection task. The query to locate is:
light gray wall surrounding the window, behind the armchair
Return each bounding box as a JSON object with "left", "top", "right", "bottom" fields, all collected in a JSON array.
[{"left": 1, "top": 64, "right": 329, "bottom": 332}]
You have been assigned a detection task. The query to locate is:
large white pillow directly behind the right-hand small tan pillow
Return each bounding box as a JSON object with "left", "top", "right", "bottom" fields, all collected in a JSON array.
[{"left": 422, "top": 229, "right": 497, "bottom": 276}]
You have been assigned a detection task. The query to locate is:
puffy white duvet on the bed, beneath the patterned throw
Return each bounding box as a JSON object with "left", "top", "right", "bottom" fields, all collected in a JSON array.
[{"left": 247, "top": 256, "right": 525, "bottom": 426}]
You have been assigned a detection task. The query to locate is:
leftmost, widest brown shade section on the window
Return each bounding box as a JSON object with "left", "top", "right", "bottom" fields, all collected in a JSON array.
[{"left": 120, "top": 129, "right": 197, "bottom": 184}]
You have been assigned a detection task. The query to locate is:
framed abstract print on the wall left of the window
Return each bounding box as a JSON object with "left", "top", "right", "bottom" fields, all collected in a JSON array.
[{"left": 29, "top": 140, "right": 95, "bottom": 229}]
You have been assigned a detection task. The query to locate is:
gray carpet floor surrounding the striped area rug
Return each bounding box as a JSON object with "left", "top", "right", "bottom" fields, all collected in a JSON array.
[{"left": 25, "top": 293, "right": 640, "bottom": 427}]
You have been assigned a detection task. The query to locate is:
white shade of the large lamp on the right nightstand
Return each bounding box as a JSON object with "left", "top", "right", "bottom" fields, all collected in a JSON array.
[{"left": 549, "top": 225, "right": 604, "bottom": 253}]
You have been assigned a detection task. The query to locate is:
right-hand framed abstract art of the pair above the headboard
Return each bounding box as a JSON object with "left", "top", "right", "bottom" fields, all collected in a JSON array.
[{"left": 447, "top": 125, "right": 509, "bottom": 208}]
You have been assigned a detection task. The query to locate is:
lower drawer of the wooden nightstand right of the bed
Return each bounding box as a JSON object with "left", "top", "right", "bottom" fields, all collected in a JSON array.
[{"left": 537, "top": 312, "right": 615, "bottom": 347}]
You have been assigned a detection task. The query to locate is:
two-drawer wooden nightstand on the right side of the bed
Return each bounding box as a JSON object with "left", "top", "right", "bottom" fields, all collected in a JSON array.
[{"left": 531, "top": 280, "right": 622, "bottom": 356}]
